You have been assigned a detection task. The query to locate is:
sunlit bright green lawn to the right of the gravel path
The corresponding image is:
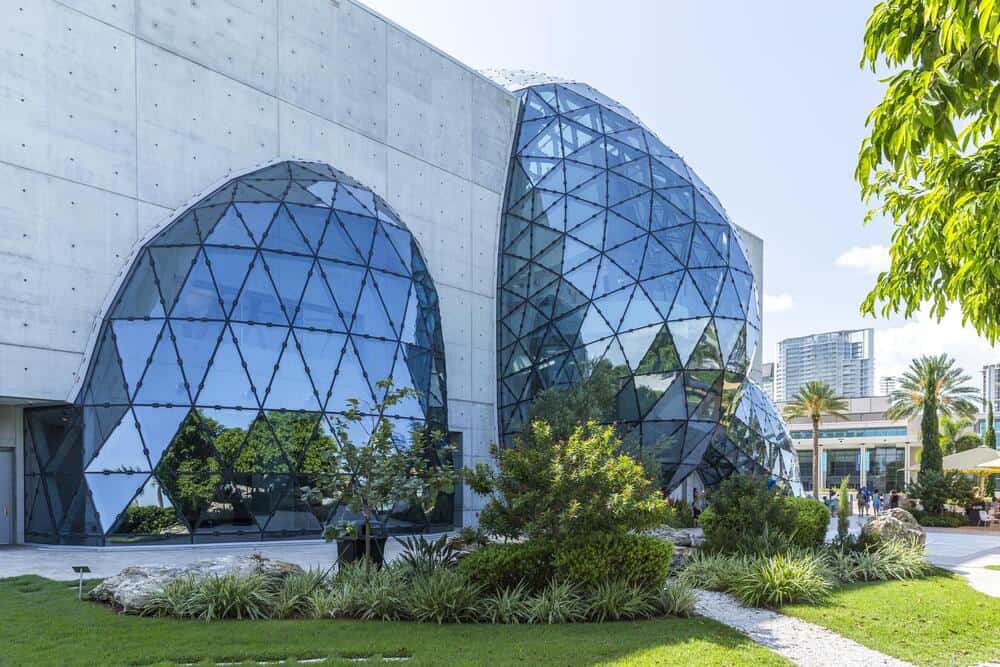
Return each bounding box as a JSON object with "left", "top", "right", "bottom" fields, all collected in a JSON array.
[{"left": 781, "top": 572, "right": 1000, "bottom": 665}]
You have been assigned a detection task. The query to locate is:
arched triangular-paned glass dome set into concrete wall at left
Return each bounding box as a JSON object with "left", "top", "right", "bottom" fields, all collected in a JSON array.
[{"left": 25, "top": 162, "right": 451, "bottom": 544}]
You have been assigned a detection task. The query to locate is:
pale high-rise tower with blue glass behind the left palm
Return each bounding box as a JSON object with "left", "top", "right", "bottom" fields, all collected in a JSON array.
[{"left": 775, "top": 329, "right": 875, "bottom": 401}]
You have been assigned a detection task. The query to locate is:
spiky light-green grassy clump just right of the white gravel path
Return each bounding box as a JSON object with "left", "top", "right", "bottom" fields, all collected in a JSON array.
[{"left": 733, "top": 554, "right": 832, "bottom": 608}]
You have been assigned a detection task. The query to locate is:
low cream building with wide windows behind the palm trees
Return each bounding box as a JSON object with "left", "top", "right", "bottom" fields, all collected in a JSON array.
[{"left": 779, "top": 396, "right": 920, "bottom": 491}]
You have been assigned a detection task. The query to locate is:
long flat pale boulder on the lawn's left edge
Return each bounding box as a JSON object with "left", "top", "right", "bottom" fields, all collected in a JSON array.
[{"left": 89, "top": 555, "right": 302, "bottom": 614}]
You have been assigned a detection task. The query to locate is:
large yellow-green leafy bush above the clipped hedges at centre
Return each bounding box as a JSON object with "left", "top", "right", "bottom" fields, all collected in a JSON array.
[{"left": 466, "top": 421, "right": 666, "bottom": 539}]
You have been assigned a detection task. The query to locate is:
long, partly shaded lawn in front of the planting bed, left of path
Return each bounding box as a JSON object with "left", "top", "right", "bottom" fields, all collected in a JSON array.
[{"left": 0, "top": 577, "right": 789, "bottom": 667}]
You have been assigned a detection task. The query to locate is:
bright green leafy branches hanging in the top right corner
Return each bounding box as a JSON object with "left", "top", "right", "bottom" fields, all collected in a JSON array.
[{"left": 856, "top": 0, "right": 1000, "bottom": 342}]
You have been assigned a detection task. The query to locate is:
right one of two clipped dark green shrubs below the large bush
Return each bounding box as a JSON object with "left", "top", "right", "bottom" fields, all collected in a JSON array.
[{"left": 554, "top": 533, "right": 674, "bottom": 589}]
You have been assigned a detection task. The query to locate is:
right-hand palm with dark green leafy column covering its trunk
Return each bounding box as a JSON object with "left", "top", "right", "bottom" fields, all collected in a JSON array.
[{"left": 886, "top": 354, "right": 978, "bottom": 473}]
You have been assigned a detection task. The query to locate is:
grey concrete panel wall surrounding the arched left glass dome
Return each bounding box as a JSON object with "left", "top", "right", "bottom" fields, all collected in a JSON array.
[{"left": 0, "top": 0, "right": 516, "bottom": 532}]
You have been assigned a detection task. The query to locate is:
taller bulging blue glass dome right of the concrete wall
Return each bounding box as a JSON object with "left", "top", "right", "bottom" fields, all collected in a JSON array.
[{"left": 488, "top": 71, "right": 798, "bottom": 489}]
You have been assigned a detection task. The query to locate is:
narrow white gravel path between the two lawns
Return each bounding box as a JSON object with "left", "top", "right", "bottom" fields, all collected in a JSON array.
[{"left": 695, "top": 590, "right": 913, "bottom": 667}]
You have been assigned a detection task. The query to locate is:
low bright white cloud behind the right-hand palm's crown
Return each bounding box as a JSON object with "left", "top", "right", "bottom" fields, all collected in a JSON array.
[{"left": 875, "top": 307, "right": 1000, "bottom": 380}]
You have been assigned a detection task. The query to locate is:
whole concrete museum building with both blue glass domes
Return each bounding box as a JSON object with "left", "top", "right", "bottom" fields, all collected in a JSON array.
[{"left": 0, "top": 0, "right": 801, "bottom": 545}]
